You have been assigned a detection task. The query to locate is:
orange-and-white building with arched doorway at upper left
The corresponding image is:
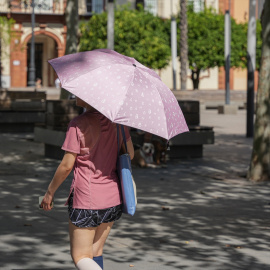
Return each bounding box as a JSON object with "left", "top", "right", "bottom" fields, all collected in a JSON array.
[{"left": 0, "top": 0, "right": 105, "bottom": 87}]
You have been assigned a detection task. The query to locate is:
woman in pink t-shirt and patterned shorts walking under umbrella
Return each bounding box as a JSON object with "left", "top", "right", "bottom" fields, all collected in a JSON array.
[{"left": 41, "top": 98, "right": 134, "bottom": 270}]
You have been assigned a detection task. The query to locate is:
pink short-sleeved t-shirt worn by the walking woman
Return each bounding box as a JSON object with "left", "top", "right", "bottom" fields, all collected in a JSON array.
[{"left": 62, "top": 111, "right": 130, "bottom": 210}]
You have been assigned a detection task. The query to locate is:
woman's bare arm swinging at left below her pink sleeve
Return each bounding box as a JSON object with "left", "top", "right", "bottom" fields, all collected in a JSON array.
[{"left": 41, "top": 152, "right": 77, "bottom": 211}]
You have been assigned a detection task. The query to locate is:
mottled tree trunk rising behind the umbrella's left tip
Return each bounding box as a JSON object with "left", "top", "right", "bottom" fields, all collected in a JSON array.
[{"left": 60, "top": 0, "right": 79, "bottom": 99}]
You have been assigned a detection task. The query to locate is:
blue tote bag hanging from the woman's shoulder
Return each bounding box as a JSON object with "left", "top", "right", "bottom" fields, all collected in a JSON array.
[{"left": 117, "top": 125, "right": 136, "bottom": 216}]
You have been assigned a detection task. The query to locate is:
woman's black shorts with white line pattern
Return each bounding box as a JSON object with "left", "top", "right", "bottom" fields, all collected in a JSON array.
[{"left": 68, "top": 191, "right": 122, "bottom": 228}]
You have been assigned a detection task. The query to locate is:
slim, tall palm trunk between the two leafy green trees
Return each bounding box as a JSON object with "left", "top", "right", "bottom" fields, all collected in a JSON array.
[{"left": 180, "top": 0, "right": 188, "bottom": 90}]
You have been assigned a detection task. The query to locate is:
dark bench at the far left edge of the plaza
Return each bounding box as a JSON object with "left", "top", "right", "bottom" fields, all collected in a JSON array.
[{"left": 0, "top": 90, "right": 46, "bottom": 132}]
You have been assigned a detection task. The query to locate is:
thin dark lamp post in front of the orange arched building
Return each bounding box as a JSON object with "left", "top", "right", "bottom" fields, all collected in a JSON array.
[{"left": 28, "top": 0, "right": 36, "bottom": 86}]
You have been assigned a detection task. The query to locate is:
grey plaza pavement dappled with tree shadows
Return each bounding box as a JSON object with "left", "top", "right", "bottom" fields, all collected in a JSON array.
[{"left": 0, "top": 110, "right": 270, "bottom": 270}]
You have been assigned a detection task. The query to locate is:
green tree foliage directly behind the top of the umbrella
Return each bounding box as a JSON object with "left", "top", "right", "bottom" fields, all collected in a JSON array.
[{"left": 80, "top": 7, "right": 171, "bottom": 69}]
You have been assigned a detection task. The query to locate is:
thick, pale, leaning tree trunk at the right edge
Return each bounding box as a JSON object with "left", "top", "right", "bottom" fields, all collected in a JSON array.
[{"left": 248, "top": 1, "right": 270, "bottom": 181}]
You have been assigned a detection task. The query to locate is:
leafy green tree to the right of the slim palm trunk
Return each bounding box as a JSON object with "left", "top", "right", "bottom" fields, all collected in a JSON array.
[{"left": 184, "top": 6, "right": 262, "bottom": 89}]
